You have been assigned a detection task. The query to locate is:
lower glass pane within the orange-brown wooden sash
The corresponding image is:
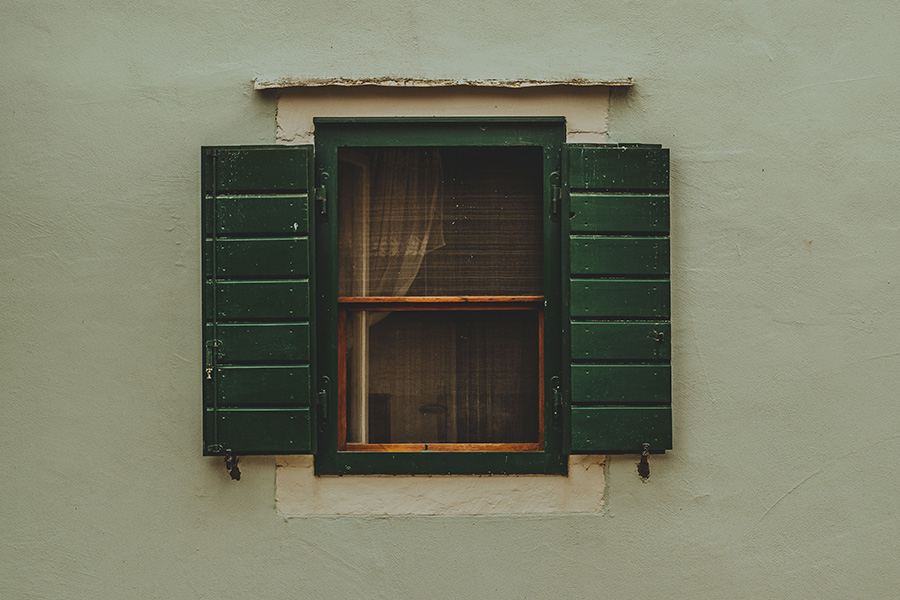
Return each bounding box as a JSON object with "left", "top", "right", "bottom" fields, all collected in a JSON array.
[{"left": 346, "top": 310, "right": 540, "bottom": 444}]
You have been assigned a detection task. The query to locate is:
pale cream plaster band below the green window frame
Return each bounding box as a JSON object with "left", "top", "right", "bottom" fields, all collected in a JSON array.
[{"left": 275, "top": 456, "right": 606, "bottom": 515}]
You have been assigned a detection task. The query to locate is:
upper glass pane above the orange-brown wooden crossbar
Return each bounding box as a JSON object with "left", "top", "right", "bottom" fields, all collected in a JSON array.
[{"left": 338, "top": 147, "right": 543, "bottom": 296}]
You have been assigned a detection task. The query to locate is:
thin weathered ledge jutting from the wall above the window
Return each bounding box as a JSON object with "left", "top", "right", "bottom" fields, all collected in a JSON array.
[{"left": 253, "top": 77, "right": 634, "bottom": 90}]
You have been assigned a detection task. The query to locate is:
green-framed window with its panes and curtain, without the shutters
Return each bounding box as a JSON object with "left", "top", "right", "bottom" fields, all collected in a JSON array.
[{"left": 315, "top": 119, "right": 566, "bottom": 473}]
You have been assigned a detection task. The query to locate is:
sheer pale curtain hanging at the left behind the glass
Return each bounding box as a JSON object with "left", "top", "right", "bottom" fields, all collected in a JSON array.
[{"left": 338, "top": 148, "right": 444, "bottom": 443}]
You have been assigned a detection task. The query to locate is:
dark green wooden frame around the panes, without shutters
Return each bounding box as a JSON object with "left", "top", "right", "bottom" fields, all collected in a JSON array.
[{"left": 314, "top": 117, "right": 567, "bottom": 475}]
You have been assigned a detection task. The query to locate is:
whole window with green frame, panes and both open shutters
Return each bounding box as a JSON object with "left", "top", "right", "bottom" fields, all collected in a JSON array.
[{"left": 203, "top": 118, "right": 671, "bottom": 474}]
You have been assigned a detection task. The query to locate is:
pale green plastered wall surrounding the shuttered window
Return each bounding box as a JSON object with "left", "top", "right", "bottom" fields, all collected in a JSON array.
[{"left": 0, "top": 0, "right": 900, "bottom": 600}]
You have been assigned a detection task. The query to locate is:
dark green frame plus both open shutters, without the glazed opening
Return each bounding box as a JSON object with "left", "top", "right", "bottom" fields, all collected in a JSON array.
[{"left": 202, "top": 117, "right": 672, "bottom": 475}]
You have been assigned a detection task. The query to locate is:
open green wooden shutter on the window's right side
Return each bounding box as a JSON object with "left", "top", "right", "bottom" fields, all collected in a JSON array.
[{"left": 563, "top": 145, "right": 672, "bottom": 454}]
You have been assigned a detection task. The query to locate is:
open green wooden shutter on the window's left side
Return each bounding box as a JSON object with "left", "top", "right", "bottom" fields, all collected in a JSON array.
[{"left": 200, "top": 146, "right": 315, "bottom": 454}]
